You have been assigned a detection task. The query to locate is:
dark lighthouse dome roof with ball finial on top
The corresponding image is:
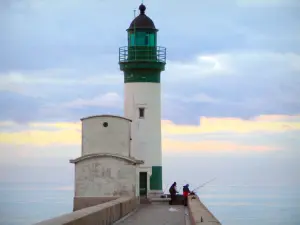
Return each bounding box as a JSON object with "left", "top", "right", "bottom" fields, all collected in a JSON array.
[{"left": 128, "top": 4, "right": 156, "bottom": 30}]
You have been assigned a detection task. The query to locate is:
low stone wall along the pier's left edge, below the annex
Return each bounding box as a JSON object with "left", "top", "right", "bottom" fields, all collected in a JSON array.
[{"left": 35, "top": 197, "right": 137, "bottom": 225}]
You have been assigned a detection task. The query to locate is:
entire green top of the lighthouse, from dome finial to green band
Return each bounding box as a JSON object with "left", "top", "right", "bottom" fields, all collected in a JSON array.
[{"left": 119, "top": 4, "right": 166, "bottom": 83}]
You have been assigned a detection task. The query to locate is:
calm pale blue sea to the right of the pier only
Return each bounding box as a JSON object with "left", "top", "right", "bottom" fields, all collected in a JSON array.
[{"left": 199, "top": 186, "right": 300, "bottom": 225}]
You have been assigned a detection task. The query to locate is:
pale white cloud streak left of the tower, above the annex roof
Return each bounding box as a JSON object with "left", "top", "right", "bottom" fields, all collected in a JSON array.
[{"left": 0, "top": 68, "right": 123, "bottom": 96}]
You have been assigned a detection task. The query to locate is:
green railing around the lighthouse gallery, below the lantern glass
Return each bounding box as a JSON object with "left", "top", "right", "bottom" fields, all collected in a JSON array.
[{"left": 119, "top": 46, "right": 166, "bottom": 63}]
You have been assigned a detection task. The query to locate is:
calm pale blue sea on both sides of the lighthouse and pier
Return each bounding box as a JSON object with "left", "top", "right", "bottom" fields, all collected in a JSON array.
[{"left": 0, "top": 183, "right": 300, "bottom": 225}]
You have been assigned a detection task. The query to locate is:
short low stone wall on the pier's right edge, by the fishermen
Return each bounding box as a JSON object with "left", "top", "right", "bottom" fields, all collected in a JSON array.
[{"left": 188, "top": 195, "right": 221, "bottom": 225}]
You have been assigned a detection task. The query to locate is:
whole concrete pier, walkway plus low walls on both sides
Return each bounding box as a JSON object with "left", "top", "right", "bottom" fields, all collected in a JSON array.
[{"left": 36, "top": 196, "right": 221, "bottom": 225}]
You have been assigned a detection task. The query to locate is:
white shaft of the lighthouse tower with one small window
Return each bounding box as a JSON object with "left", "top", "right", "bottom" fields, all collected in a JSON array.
[{"left": 124, "top": 83, "right": 162, "bottom": 167}]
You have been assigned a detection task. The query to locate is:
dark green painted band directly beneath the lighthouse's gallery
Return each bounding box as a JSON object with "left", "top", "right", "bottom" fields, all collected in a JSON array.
[{"left": 124, "top": 70, "right": 160, "bottom": 83}]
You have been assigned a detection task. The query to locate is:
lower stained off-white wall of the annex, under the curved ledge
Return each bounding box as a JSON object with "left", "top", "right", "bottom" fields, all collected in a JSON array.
[{"left": 75, "top": 157, "right": 136, "bottom": 197}]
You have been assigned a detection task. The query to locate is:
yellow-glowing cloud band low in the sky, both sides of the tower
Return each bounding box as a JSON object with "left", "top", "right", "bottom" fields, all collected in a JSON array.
[{"left": 0, "top": 115, "right": 300, "bottom": 152}]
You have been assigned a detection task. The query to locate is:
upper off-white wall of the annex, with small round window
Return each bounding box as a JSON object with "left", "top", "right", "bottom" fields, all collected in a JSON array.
[{"left": 82, "top": 116, "right": 130, "bottom": 156}]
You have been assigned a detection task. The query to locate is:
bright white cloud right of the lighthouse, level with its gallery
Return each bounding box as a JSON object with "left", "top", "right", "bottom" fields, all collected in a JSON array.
[{"left": 163, "top": 51, "right": 300, "bottom": 85}]
